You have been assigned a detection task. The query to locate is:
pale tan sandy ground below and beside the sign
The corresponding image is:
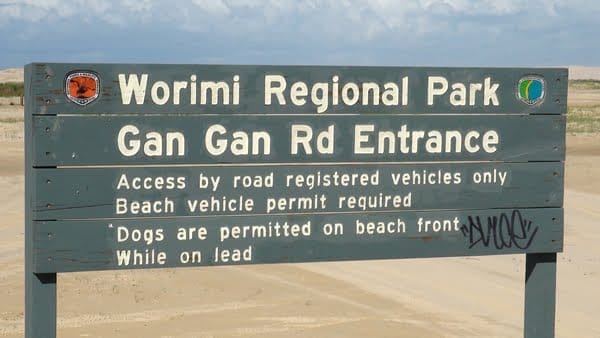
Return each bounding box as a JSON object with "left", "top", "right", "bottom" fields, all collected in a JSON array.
[{"left": 0, "top": 70, "right": 600, "bottom": 338}]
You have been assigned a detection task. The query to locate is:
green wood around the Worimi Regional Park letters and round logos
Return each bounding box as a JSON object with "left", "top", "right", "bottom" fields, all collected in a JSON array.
[{"left": 27, "top": 63, "right": 568, "bottom": 114}]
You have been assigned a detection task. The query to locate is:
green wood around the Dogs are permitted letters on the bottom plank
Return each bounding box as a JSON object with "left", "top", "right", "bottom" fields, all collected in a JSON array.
[{"left": 34, "top": 208, "right": 563, "bottom": 272}]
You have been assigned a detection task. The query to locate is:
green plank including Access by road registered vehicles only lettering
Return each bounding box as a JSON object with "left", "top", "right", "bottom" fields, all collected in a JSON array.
[{"left": 32, "top": 162, "right": 563, "bottom": 220}]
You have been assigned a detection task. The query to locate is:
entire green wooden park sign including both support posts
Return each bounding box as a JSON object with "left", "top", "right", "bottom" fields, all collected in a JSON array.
[{"left": 25, "top": 63, "right": 567, "bottom": 337}]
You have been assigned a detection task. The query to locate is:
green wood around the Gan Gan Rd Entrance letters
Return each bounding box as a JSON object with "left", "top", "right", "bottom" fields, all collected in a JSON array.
[{"left": 33, "top": 115, "right": 565, "bottom": 167}]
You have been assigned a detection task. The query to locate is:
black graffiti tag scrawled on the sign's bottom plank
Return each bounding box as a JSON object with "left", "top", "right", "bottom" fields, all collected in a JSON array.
[{"left": 460, "top": 210, "right": 539, "bottom": 250}]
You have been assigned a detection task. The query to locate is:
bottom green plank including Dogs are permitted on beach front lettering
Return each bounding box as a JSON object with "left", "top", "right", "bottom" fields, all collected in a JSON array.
[{"left": 33, "top": 208, "right": 563, "bottom": 273}]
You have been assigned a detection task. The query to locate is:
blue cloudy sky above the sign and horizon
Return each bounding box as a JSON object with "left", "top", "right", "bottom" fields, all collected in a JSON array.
[{"left": 0, "top": 0, "right": 600, "bottom": 68}]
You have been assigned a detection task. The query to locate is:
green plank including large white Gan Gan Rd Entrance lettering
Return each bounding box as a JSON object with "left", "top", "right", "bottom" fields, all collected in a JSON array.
[{"left": 33, "top": 115, "right": 565, "bottom": 166}]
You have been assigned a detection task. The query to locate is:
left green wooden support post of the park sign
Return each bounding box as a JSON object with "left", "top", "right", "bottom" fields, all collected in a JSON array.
[{"left": 25, "top": 64, "right": 56, "bottom": 338}]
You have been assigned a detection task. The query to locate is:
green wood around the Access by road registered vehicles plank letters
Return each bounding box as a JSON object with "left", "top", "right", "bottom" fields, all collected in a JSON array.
[{"left": 33, "top": 162, "right": 564, "bottom": 220}]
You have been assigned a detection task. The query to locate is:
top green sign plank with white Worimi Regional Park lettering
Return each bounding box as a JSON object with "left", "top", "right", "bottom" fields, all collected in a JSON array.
[{"left": 31, "top": 63, "right": 568, "bottom": 115}]
